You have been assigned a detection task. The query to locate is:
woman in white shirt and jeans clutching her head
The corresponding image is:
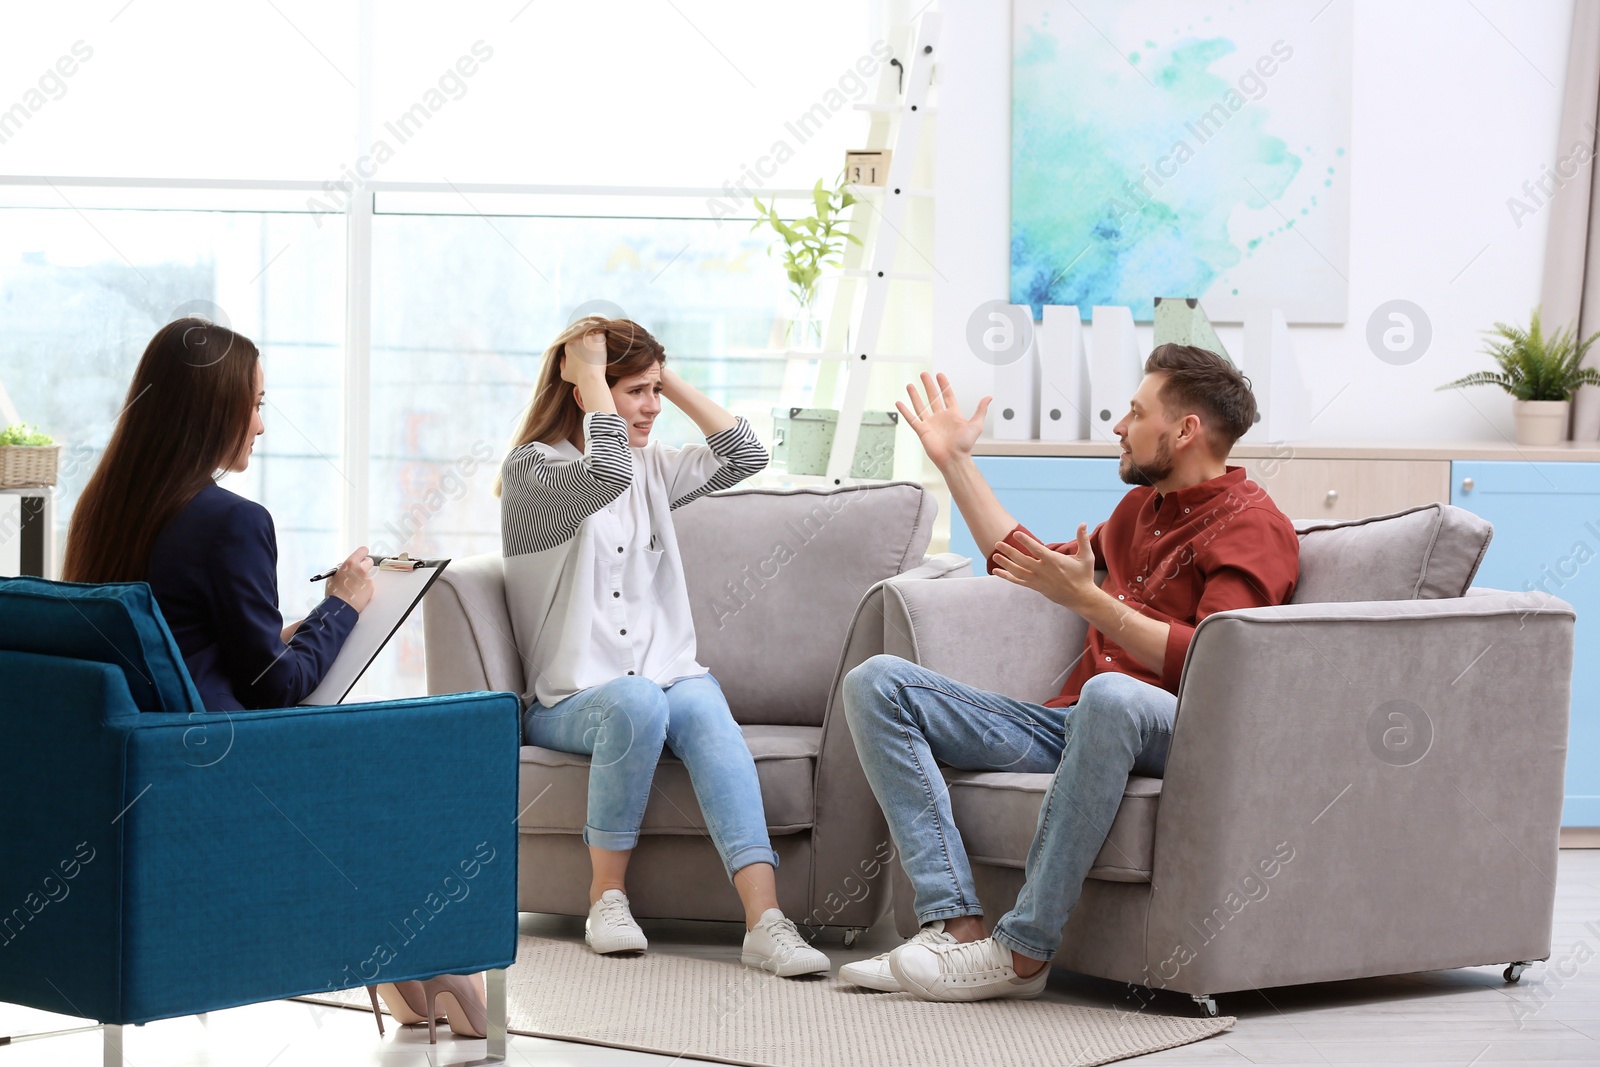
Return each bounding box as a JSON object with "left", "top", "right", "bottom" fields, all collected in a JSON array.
[{"left": 496, "top": 317, "right": 829, "bottom": 977}]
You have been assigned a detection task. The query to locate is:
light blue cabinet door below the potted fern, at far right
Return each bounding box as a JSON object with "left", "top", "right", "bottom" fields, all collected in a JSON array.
[{"left": 1450, "top": 461, "right": 1600, "bottom": 827}]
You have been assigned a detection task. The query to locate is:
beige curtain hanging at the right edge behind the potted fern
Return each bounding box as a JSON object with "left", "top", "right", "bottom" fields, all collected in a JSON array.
[{"left": 1541, "top": 0, "right": 1600, "bottom": 442}]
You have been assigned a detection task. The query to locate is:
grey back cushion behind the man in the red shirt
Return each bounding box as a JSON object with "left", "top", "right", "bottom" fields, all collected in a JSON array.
[{"left": 1290, "top": 504, "right": 1494, "bottom": 603}]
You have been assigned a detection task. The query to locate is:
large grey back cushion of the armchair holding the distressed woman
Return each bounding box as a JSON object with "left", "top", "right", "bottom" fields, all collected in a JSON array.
[{"left": 672, "top": 482, "right": 934, "bottom": 726}]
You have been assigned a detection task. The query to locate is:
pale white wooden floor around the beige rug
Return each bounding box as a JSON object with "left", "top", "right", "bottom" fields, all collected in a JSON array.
[{"left": 0, "top": 849, "right": 1600, "bottom": 1067}]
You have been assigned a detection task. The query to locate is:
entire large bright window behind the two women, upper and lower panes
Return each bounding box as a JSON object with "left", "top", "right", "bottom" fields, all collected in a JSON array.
[{"left": 0, "top": 0, "right": 888, "bottom": 696}]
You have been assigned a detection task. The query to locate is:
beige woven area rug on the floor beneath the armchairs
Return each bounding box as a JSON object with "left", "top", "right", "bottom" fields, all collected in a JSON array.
[{"left": 306, "top": 936, "right": 1234, "bottom": 1067}]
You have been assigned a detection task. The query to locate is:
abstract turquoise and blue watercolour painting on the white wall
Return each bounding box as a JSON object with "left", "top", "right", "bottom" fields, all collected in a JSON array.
[{"left": 1011, "top": 0, "right": 1350, "bottom": 323}]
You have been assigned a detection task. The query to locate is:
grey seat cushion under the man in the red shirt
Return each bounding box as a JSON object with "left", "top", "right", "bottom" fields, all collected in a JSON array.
[{"left": 944, "top": 768, "right": 1162, "bottom": 881}]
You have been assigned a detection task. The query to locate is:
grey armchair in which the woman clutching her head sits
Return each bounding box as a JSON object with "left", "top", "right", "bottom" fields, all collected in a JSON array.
[{"left": 422, "top": 483, "right": 968, "bottom": 941}]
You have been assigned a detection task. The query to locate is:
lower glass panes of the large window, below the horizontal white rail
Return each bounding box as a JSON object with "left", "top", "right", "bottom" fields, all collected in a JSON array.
[{"left": 0, "top": 189, "right": 810, "bottom": 696}]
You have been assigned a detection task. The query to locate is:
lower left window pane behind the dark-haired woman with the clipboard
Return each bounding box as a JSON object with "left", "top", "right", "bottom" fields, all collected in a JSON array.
[{"left": 0, "top": 195, "right": 349, "bottom": 617}]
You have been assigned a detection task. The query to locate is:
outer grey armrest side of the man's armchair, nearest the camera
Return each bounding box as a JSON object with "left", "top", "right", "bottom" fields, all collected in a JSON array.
[{"left": 1146, "top": 592, "right": 1574, "bottom": 993}]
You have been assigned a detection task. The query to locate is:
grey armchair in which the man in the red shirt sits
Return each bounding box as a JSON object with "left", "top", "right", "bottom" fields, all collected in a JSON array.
[{"left": 883, "top": 504, "right": 1573, "bottom": 1014}]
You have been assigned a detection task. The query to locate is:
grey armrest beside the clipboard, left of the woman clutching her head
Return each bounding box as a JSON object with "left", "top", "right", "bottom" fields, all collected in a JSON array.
[{"left": 422, "top": 552, "right": 531, "bottom": 696}]
